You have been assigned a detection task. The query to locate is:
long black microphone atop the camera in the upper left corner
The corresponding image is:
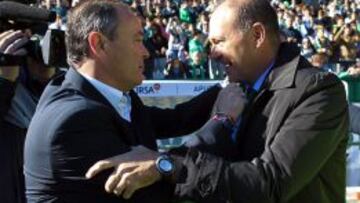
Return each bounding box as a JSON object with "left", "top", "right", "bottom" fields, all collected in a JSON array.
[{"left": 0, "top": 1, "right": 56, "bottom": 22}]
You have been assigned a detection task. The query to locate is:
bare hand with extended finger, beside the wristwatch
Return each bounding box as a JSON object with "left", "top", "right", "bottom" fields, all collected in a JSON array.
[{"left": 86, "top": 146, "right": 161, "bottom": 199}]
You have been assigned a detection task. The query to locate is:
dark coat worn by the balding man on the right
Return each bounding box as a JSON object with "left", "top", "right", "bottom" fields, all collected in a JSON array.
[{"left": 176, "top": 44, "right": 349, "bottom": 203}]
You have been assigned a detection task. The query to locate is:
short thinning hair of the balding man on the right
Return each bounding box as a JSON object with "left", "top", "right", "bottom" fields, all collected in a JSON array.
[{"left": 234, "top": 0, "right": 280, "bottom": 39}]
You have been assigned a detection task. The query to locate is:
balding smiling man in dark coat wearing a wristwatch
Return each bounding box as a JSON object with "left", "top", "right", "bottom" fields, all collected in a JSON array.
[{"left": 87, "top": 0, "right": 349, "bottom": 203}]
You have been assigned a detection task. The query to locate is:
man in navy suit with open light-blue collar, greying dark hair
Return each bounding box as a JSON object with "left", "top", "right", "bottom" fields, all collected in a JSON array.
[{"left": 24, "top": 0, "right": 219, "bottom": 203}]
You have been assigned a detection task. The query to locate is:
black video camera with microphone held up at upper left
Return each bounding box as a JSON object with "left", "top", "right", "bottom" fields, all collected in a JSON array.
[{"left": 0, "top": 1, "right": 68, "bottom": 67}]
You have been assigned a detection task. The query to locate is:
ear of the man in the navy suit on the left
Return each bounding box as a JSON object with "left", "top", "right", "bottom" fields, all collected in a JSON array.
[{"left": 87, "top": 32, "right": 106, "bottom": 58}]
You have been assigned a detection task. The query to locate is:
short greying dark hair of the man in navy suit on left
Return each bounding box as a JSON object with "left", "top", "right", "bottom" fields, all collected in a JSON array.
[{"left": 65, "top": 0, "right": 122, "bottom": 64}]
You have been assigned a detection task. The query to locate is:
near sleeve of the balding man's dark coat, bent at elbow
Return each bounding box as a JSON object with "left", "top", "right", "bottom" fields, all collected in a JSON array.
[{"left": 175, "top": 75, "right": 348, "bottom": 203}]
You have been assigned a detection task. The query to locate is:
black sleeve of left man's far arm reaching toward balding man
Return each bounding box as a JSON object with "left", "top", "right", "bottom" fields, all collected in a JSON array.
[{"left": 145, "top": 85, "right": 221, "bottom": 139}]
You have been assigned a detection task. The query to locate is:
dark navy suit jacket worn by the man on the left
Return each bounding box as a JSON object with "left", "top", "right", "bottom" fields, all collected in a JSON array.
[{"left": 24, "top": 69, "right": 219, "bottom": 203}]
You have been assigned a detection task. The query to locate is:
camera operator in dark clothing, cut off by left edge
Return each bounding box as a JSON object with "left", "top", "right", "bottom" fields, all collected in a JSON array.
[{"left": 0, "top": 30, "right": 55, "bottom": 203}]
